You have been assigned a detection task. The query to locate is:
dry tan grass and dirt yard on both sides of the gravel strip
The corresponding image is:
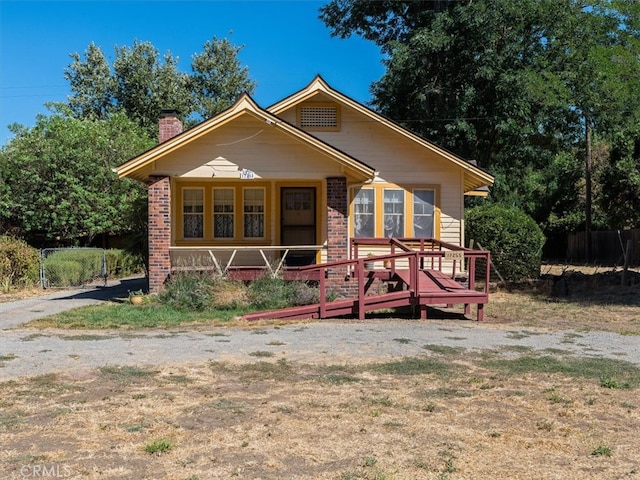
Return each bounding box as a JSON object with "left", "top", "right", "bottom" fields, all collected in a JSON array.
[{"left": 0, "top": 266, "right": 640, "bottom": 480}]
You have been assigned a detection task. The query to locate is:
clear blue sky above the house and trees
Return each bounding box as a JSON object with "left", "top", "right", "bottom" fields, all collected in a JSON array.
[{"left": 0, "top": 0, "right": 384, "bottom": 145}]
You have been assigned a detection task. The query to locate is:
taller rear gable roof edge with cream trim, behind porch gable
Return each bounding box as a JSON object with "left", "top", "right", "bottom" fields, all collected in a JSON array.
[{"left": 267, "top": 75, "right": 494, "bottom": 195}]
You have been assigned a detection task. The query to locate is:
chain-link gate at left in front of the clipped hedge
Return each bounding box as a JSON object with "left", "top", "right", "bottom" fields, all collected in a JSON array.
[{"left": 40, "top": 248, "right": 107, "bottom": 288}]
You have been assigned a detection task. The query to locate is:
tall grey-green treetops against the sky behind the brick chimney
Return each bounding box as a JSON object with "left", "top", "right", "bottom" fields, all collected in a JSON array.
[{"left": 65, "top": 37, "right": 255, "bottom": 134}]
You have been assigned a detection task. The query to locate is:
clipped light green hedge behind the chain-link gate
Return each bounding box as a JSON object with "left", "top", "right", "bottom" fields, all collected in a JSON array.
[{"left": 43, "top": 249, "right": 105, "bottom": 287}]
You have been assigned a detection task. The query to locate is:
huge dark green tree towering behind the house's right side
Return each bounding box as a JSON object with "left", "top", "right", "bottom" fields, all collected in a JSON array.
[{"left": 320, "top": 0, "right": 640, "bottom": 244}]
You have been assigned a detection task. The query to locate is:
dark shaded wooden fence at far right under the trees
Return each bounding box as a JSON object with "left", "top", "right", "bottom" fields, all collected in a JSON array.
[{"left": 567, "top": 229, "right": 640, "bottom": 267}]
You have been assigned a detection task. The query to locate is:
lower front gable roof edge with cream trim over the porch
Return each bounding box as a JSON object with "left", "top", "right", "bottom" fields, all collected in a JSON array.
[{"left": 114, "top": 93, "right": 376, "bottom": 182}]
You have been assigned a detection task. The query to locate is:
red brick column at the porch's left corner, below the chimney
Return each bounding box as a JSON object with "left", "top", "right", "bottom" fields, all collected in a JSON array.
[{"left": 148, "top": 176, "right": 171, "bottom": 293}]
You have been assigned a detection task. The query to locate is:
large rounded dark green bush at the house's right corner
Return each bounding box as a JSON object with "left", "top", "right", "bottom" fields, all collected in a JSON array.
[{"left": 465, "top": 204, "right": 545, "bottom": 281}]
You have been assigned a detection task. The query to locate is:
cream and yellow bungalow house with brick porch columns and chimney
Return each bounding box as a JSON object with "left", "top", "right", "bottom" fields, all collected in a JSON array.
[{"left": 116, "top": 76, "right": 493, "bottom": 300}]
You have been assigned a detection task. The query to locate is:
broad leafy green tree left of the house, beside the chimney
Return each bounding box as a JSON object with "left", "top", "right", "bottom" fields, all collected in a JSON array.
[{"left": 0, "top": 110, "right": 154, "bottom": 242}]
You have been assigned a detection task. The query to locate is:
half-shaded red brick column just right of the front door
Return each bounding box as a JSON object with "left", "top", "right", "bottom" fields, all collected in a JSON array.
[{"left": 327, "top": 177, "right": 349, "bottom": 295}]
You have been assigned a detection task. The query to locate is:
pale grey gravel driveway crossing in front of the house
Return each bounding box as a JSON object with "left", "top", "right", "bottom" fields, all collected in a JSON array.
[{"left": 0, "top": 279, "right": 640, "bottom": 380}]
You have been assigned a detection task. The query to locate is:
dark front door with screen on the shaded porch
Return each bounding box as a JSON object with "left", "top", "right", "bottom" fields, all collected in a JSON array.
[{"left": 280, "top": 187, "right": 316, "bottom": 266}]
